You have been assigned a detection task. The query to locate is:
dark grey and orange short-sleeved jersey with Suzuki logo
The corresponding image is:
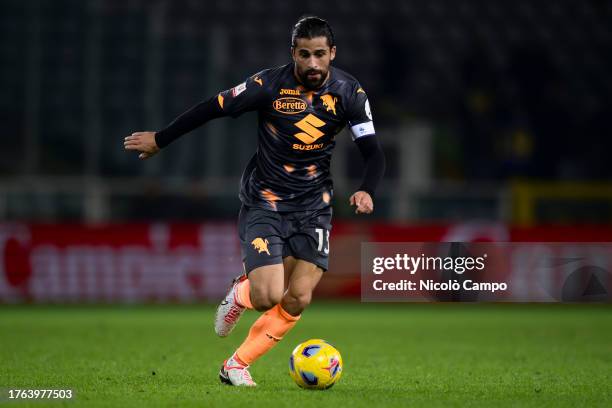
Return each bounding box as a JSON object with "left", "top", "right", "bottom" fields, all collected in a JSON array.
[{"left": 216, "top": 64, "right": 375, "bottom": 211}]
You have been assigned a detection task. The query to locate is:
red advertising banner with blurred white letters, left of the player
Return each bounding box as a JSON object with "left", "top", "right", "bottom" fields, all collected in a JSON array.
[{"left": 0, "top": 223, "right": 242, "bottom": 302}]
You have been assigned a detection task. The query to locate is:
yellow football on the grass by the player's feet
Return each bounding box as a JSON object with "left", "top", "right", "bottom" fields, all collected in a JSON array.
[{"left": 289, "top": 339, "right": 342, "bottom": 390}]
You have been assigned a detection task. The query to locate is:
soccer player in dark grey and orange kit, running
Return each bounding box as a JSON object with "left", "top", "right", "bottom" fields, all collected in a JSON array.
[{"left": 124, "top": 17, "right": 385, "bottom": 386}]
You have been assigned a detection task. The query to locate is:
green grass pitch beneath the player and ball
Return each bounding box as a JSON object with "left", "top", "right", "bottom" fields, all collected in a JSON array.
[{"left": 0, "top": 302, "right": 612, "bottom": 408}]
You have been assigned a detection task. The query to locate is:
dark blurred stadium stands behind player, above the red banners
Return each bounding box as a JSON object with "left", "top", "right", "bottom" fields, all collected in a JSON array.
[{"left": 0, "top": 0, "right": 612, "bottom": 223}]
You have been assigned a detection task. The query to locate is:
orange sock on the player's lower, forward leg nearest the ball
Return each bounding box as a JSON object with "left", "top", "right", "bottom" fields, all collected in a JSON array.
[{"left": 236, "top": 304, "right": 300, "bottom": 365}]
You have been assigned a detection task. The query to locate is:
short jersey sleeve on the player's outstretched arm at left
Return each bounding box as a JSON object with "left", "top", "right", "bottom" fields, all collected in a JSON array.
[{"left": 217, "top": 73, "right": 268, "bottom": 118}]
